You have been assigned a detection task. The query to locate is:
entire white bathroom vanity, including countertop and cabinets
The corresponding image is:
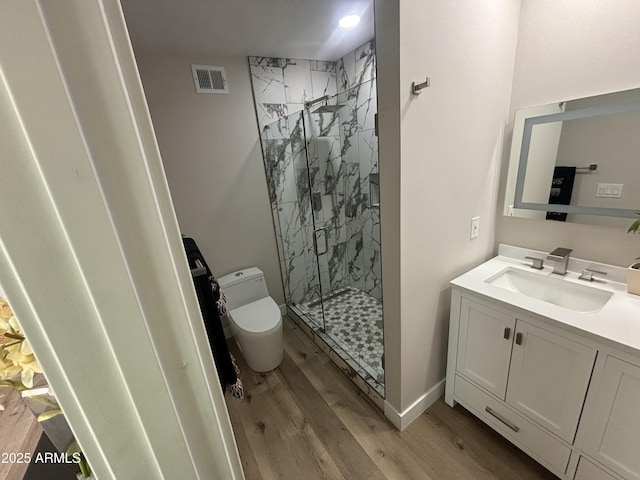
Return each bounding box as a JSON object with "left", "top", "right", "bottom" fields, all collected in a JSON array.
[{"left": 445, "top": 251, "right": 640, "bottom": 480}]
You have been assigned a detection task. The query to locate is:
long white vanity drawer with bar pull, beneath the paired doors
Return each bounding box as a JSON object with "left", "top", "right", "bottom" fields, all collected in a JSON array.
[{"left": 454, "top": 375, "right": 571, "bottom": 475}]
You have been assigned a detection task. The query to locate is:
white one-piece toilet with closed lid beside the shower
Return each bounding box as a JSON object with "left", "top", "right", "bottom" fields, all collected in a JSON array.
[{"left": 218, "top": 267, "right": 282, "bottom": 372}]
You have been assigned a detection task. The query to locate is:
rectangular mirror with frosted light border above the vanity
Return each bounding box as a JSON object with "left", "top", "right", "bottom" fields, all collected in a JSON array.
[{"left": 504, "top": 88, "right": 640, "bottom": 225}]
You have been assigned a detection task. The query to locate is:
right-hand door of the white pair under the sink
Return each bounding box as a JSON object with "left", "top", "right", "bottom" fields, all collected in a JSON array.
[{"left": 507, "top": 319, "right": 596, "bottom": 443}]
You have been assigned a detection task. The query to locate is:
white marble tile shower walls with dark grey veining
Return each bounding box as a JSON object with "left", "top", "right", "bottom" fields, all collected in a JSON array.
[{"left": 249, "top": 42, "right": 382, "bottom": 303}]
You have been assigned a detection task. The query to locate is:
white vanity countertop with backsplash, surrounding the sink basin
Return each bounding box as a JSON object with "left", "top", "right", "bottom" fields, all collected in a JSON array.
[{"left": 451, "top": 245, "right": 640, "bottom": 354}]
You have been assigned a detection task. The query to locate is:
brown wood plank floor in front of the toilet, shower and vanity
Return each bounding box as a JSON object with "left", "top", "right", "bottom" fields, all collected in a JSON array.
[{"left": 227, "top": 319, "right": 557, "bottom": 480}]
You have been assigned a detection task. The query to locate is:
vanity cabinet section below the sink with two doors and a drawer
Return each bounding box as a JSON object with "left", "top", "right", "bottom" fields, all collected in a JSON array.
[{"left": 446, "top": 289, "right": 604, "bottom": 480}]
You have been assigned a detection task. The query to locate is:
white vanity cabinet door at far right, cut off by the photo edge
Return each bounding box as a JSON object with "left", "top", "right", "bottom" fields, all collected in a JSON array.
[{"left": 583, "top": 356, "right": 640, "bottom": 480}]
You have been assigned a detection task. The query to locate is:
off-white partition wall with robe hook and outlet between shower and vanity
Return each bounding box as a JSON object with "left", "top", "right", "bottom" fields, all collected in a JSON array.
[{"left": 376, "top": 0, "right": 519, "bottom": 420}]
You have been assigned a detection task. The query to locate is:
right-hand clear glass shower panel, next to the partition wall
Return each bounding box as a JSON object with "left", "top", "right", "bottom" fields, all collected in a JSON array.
[{"left": 304, "top": 80, "right": 384, "bottom": 385}]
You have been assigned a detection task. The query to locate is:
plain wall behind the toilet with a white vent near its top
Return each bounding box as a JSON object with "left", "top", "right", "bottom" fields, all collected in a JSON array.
[{"left": 136, "top": 52, "right": 284, "bottom": 304}]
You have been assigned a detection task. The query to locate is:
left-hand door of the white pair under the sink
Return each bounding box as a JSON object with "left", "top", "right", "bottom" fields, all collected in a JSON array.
[{"left": 456, "top": 298, "right": 516, "bottom": 400}]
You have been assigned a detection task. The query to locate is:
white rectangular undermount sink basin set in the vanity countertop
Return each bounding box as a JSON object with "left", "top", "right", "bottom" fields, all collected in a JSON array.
[{"left": 485, "top": 267, "right": 613, "bottom": 313}]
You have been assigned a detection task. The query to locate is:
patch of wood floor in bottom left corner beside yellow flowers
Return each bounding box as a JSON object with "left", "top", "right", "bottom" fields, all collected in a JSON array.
[{"left": 0, "top": 388, "right": 42, "bottom": 480}]
